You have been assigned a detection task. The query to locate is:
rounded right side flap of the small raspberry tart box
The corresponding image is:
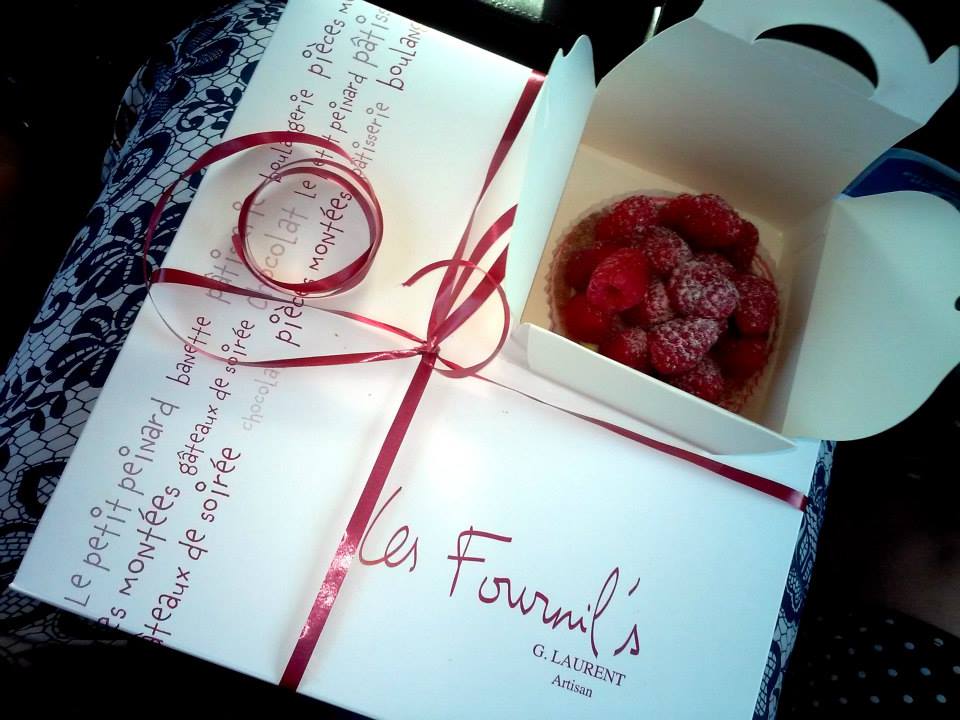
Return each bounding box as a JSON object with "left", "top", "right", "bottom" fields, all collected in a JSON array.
[{"left": 765, "top": 191, "right": 960, "bottom": 440}]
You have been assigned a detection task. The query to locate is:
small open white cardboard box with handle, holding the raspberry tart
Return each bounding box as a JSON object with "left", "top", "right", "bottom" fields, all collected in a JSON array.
[{"left": 506, "top": 0, "right": 960, "bottom": 453}]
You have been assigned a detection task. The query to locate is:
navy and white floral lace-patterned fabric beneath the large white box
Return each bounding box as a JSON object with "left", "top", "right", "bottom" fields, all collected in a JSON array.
[{"left": 0, "top": 0, "right": 833, "bottom": 718}]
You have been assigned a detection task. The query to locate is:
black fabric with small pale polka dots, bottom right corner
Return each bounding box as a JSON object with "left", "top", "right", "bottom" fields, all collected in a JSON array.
[{"left": 777, "top": 609, "right": 960, "bottom": 720}]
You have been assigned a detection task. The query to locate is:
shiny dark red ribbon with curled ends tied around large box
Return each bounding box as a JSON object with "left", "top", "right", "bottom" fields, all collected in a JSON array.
[{"left": 144, "top": 73, "right": 806, "bottom": 689}]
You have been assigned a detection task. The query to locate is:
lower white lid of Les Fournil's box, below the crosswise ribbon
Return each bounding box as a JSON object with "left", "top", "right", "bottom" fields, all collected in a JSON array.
[{"left": 14, "top": 296, "right": 817, "bottom": 718}]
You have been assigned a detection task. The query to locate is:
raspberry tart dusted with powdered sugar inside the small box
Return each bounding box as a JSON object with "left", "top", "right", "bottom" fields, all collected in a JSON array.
[{"left": 549, "top": 194, "right": 779, "bottom": 411}]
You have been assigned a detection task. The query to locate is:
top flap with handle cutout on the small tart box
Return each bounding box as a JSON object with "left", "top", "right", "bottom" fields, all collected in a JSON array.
[{"left": 584, "top": 0, "right": 958, "bottom": 225}]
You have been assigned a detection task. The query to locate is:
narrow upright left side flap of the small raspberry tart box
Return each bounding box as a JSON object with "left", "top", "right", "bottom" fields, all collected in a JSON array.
[{"left": 503, "top": 36, "right": 596, "bottom": 319}]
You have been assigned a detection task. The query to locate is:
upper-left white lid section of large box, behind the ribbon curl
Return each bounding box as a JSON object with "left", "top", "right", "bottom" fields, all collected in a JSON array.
[{"left": 158, "top": 3, "right": 530, "bottom": 356}]
